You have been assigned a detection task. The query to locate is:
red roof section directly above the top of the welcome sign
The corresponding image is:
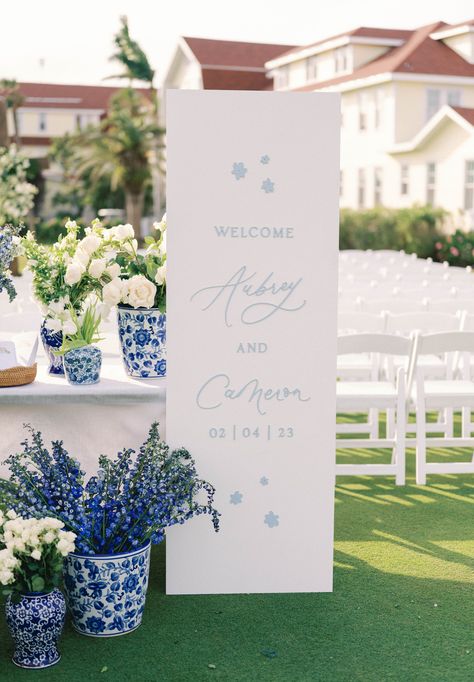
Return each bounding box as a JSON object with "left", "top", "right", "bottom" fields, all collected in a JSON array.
[{"left": 183, "top": 36, "right": 293, "bottom": 70}]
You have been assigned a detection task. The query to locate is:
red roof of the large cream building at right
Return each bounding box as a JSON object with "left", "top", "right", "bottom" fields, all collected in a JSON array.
[{"left": 299, "top": 21, "right": 474, "bottom": 90}]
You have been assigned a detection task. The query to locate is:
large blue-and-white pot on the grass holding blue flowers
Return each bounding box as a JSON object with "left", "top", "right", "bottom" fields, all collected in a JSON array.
[{"left": 64, "top": 543, "right": 150, "bottom": 637}]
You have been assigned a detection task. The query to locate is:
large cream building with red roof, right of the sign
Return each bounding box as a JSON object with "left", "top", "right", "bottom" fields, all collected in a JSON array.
[{"left": 266, "top": 20, "right": 474, "bottom": 223}]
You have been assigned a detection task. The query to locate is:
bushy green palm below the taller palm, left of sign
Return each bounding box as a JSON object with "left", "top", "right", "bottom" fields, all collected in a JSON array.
[{"left": 77, "top": 88, "right": 162, "bottom": 239}]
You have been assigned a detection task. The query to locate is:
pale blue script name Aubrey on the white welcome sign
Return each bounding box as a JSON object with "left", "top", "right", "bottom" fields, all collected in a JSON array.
[{"left": 191, "top": 265, "right": 306, "bottom": 327}]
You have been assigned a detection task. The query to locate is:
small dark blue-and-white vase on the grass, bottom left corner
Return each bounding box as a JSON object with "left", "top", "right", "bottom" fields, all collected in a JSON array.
[{"left": 6, "top": 589, "right": 66, "bottom": 668}]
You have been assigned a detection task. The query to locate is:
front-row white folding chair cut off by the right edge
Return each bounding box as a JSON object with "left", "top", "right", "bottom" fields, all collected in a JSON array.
[{"left": 408, "top": 331, "right": 474, "bottom": 485}]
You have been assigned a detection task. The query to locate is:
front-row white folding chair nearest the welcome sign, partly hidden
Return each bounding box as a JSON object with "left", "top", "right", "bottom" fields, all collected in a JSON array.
[{"left": 336, "top": 334, "right": 412, "bottom": 485}]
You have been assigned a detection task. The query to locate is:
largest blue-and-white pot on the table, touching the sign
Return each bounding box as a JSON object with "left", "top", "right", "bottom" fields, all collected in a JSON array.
[{"left": 118, "top": 306, "right": 166, "bottom": 379}]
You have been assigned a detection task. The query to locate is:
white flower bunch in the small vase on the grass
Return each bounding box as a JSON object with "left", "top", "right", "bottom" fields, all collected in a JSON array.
[{"left": 0, "top": 509, "right": 76, "bottom": 602}]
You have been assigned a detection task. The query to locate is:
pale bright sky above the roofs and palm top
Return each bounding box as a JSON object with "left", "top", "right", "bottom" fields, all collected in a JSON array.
[{"left": 0, "top": 0, "right": 474, "bottom": 85}]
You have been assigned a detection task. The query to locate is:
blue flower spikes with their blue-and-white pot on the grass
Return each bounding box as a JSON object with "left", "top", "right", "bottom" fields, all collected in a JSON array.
[{"left": 0, "top": 423, "right": 220, "bottom": 637}]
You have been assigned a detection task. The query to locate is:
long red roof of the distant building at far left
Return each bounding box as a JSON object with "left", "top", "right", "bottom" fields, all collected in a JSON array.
[{"left": 8, "top": 83, "right": 148, "bottom": 111}]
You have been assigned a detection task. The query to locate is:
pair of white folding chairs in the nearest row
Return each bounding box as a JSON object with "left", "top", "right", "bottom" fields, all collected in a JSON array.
[{"left": 336, "top": 331, "right": 474, "bottom": 485}]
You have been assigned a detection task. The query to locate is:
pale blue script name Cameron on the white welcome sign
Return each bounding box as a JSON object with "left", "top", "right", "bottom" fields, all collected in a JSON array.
[{"left": 196, "top": 374, "right": 311, "bottom": 415}]
